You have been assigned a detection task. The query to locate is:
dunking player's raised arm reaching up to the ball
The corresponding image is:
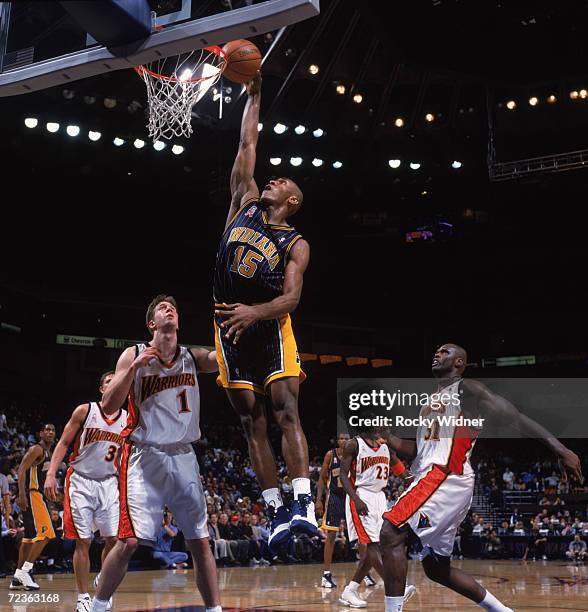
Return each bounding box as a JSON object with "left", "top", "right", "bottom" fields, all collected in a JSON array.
[{"left": 225, "top": 73, "right": 261, "bottom": 229}]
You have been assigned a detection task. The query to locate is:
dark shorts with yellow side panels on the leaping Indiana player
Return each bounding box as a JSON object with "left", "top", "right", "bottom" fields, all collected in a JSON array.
[{"left": 214, "top": 304, "right": 306, "bottom": 395}]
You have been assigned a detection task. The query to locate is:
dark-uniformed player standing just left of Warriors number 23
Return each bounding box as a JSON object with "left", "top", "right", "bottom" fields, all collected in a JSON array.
[{"left": 316, "top": 433, "right": 349, "bottom": 589}]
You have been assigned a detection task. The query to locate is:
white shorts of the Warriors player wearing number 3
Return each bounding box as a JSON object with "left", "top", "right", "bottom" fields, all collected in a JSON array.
[{"left": 63, "top": 467, "right": 119, "bottom": 539}]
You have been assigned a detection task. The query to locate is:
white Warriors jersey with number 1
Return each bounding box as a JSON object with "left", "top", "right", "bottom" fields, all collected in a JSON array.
[{"left": 122, "top": 344, "right": 200, "bottom": 446}]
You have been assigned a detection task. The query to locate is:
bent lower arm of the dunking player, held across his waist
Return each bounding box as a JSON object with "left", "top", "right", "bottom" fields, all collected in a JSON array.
[{"left": 217, "top": 239, "right": 310, "bottom": 344}]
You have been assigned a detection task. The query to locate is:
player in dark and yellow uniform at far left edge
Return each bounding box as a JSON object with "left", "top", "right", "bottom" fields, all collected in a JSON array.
[{"left": 10, "top": 423, "right": 55, "bottom": 591}]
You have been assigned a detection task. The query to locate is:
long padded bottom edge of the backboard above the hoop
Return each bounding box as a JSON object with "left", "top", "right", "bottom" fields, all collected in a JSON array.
[{"left": 0, "top": 0, "right": 320, "bottom": 97}]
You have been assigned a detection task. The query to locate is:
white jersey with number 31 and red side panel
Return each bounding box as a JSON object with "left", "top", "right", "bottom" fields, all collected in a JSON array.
[{"left": 410, "top": 379, "right": 478, "bottom": 475}]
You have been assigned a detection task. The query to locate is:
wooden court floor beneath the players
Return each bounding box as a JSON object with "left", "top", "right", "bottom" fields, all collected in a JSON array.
[{"left": 0, "top": 560, "right": 588, "bottom": 612}]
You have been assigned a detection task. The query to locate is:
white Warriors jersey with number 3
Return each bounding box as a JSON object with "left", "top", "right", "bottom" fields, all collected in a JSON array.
[{"left": 69, "top": 402, "right": 127, "bottom": 478}]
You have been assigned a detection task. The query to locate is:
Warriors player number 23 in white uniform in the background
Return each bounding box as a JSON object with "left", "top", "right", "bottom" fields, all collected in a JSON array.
[{"left": 339, "top": 420, "right": 416, "bottom": 608}]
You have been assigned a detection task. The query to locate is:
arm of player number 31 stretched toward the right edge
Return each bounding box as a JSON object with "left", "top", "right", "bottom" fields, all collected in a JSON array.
[{"left": 462, "top": 379, "right": 584, "bottom": 482}]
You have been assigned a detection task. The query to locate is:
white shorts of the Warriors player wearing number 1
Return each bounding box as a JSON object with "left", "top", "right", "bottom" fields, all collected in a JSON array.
[{"left": 118, "top": 442, "right": 208, "bottom": 546}]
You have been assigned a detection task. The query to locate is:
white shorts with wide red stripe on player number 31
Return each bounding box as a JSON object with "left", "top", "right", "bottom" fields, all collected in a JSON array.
[{"left": 384, "top": 465, "right": 475, "bottom": 557}]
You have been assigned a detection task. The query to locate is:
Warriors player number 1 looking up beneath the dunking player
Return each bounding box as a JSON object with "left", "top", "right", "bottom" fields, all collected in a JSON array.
[{"left": 92, "top": 295, "right": 221, "bottom": 612}]
